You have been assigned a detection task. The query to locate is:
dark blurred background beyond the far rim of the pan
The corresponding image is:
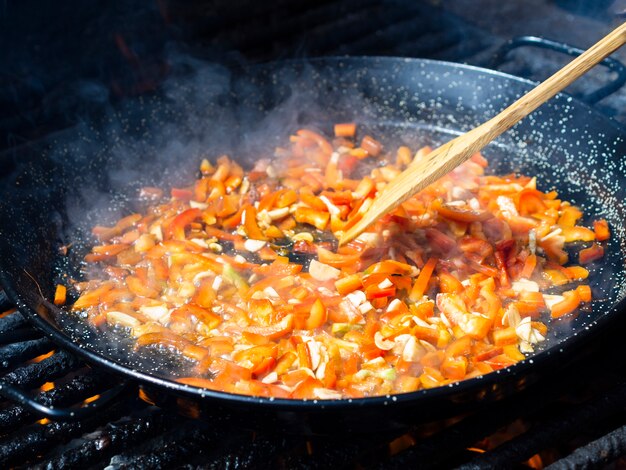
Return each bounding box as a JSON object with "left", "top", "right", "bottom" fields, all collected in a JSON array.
[{"left": 0, "top": 0, "right": 626, "bottom": 155}]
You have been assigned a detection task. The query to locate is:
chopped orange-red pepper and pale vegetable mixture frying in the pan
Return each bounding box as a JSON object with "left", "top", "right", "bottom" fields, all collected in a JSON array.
[{"left": 66, "top": 123, "right": 609, "bottom": 399}]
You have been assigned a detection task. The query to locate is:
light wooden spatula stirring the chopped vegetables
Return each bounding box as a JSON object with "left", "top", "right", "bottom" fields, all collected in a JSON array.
[{"left": 339, "top": 23, "right": 626, "bottom": 245}]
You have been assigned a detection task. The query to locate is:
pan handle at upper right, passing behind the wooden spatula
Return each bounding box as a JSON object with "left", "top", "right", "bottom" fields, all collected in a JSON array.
[{"left": 489, "top": 36, "right": 626, "bottom": 105}]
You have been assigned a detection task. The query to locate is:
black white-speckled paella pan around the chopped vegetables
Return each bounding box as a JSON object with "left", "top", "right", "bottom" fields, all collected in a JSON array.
[{"left": 0, "top": 58, "right": 626, "bottom": 433}]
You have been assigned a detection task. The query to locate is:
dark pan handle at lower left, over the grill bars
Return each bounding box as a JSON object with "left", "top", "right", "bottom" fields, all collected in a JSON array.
[{"left": 0, "top": 380, "right": 134, "bottom": 421}]
